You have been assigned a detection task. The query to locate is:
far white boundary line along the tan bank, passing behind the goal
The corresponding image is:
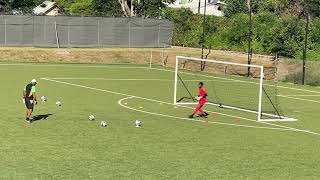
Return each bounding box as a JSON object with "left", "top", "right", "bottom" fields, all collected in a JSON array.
[{"left": 0, "top": 63, "right": 320, "bottom": 94}]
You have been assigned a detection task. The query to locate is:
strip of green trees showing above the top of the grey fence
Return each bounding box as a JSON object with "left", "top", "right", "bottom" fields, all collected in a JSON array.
[{"left": 0, "top": 0, "right": 175, "bottom": 17}]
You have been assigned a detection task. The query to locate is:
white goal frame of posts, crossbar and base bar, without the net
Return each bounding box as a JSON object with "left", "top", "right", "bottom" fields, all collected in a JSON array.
[{"left": 173, "top": 56, "right": 296, "bottom": 122}]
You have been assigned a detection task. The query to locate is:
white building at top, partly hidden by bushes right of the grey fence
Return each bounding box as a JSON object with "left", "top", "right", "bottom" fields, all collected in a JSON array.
[{"left": 169, "top": 0, "right": 225, "bottom": 16}]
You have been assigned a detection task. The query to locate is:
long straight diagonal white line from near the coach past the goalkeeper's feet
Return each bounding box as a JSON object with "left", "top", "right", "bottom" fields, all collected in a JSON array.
[{"left": 41, "top": 78, "right": 320, "bottom": 135}]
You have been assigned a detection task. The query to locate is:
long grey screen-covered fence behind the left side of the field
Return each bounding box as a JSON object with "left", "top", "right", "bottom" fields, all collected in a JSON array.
[{"left": 0, "top": 15, "right": 173, "bottom": 48}]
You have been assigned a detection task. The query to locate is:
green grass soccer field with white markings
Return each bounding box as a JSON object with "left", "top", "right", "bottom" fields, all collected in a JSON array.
[{"left": 0, "top": 63, "right": 320, "bottom": 180}]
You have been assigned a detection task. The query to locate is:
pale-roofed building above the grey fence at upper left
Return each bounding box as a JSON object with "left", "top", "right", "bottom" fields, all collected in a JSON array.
[{"left": 33, "top": 1, "right": 61, "bottom": 16}]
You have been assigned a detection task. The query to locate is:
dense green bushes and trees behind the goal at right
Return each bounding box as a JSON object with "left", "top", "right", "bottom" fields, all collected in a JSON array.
[{"left": 165, "top": 0, "right": 320, "bottom": 60}]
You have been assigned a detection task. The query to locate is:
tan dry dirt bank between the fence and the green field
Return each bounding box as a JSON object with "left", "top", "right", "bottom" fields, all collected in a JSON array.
[{"left": 0, "top": 47, "right": 280, "bottom": 79}]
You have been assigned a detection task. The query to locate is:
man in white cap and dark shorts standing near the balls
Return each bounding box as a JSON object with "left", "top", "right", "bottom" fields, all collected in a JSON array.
[{"left": 23, "top": 79, "right": 37, "bottom": 123}]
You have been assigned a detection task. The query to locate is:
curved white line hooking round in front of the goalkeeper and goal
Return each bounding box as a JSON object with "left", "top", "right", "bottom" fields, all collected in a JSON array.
[{"left": 118, "top": 96, "right": 295, "bottom": 131}]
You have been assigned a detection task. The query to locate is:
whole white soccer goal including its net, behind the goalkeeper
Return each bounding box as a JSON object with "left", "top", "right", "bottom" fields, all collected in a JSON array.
[{"left": 174, "top": 56, "right": 296, "bottom": 121}]
